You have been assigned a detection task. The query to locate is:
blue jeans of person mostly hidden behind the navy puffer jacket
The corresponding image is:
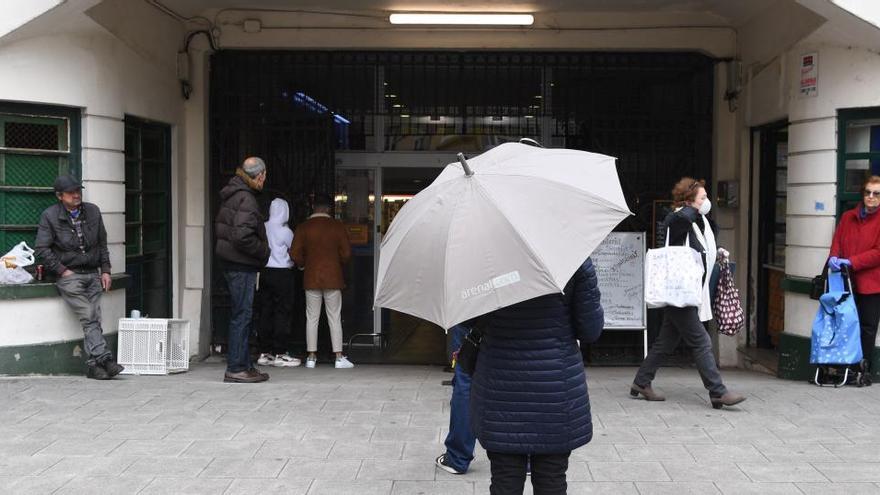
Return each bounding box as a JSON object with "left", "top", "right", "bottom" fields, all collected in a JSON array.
[{"left": 444, "top": 325, "right": 477, "bottom": 473}]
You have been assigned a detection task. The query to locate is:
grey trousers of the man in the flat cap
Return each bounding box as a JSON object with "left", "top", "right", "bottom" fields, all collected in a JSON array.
[{"left": 55, "top": 270, "right": 112, "bottom": 366}]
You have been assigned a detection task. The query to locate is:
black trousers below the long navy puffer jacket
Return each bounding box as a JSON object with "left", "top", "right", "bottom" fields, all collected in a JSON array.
[{"left": 486, "top": 452, "right": 571, "bottom": 495}]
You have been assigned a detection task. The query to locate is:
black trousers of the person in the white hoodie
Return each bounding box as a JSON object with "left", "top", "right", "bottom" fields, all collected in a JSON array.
[{"left": 259, "top": 268, "right": 294, "bottom": 354}]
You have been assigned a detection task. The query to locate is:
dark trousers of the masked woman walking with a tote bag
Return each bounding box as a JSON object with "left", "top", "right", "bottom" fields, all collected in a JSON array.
[{"left": 633, "top": 306, "right": 727, "bottom": 397}]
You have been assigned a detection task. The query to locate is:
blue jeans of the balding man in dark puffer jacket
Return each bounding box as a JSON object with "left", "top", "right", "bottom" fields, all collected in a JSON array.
[{"left": 223, "top": 270, "right": 257, "bottom": 373}]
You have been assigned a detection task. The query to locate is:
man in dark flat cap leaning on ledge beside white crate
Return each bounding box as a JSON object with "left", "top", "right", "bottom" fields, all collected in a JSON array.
[{"left": 35, "top": 175, "right": 124, "bottom": 380}]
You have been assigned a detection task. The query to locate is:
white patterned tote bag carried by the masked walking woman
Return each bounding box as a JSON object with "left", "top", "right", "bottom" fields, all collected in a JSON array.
[{"left": 645, "top": 229, "right": 704, "bottom": 308}]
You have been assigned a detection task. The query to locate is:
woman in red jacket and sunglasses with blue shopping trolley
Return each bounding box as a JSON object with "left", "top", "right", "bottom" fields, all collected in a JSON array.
[{"left": 828, "top": 175, "right": 880, "bottom": 385}]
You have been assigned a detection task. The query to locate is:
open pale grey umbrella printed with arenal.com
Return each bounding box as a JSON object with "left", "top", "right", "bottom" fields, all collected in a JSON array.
[{"left": 375, "top": 143, "right": 631, "bottom": 328}]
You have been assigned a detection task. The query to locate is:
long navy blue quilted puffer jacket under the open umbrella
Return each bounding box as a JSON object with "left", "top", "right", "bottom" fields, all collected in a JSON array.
[{"left": 471, "top": 258, "right": 604, "bottom": 454}]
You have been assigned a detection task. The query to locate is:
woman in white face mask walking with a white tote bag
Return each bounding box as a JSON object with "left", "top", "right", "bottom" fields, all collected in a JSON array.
[{"left": 630, "top": 177, "right": 745, "bottom": 409}]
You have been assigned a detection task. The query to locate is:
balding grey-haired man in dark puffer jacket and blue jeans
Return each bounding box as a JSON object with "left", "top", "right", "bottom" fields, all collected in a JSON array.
[{"left": 214, "top": 157, "right": 269, "bottom": 383}]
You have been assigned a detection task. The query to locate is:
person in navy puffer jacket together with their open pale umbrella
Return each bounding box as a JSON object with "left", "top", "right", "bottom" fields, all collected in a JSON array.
[{"left": 375, "top": 143, "right": 632, "bottom": 494}]
